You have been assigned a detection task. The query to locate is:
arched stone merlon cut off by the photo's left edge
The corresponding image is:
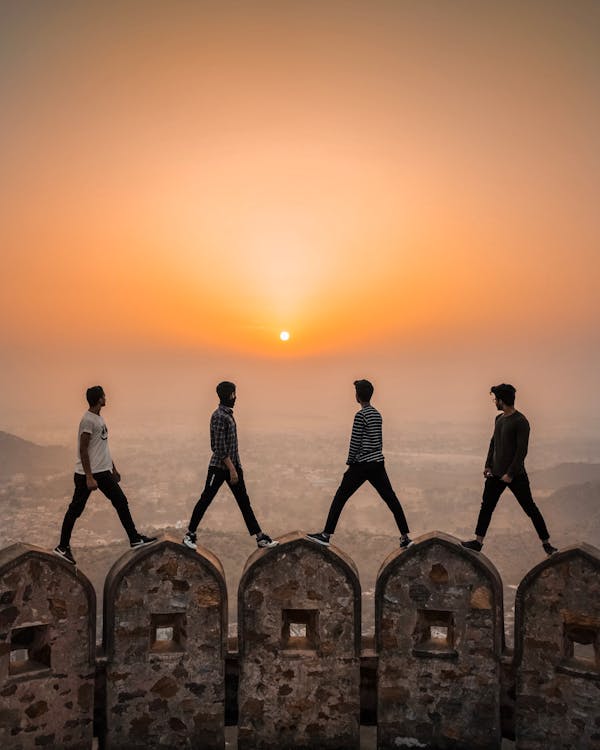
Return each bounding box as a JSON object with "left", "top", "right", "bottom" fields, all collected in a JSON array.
[{"left": 0, "top": 543, "right": 96, "bottom": 750}]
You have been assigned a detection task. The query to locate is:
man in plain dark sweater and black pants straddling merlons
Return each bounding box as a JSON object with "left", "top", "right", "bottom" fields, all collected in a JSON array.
[{"left": 462, "top": 383, "right": 557, "bottom": 555}]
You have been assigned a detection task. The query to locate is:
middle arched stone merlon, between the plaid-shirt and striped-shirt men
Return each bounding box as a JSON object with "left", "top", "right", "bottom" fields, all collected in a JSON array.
[{"left": 238, "top": 532, "right": 361, "bottom": 750}]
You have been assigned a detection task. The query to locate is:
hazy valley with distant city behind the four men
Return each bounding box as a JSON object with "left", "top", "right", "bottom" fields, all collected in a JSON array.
[{"left": 0, "top": 423, "right": 600, "bottom": 643}]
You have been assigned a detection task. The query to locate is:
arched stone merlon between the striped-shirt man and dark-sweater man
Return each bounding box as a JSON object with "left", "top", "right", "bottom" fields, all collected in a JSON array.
[{"left": 375, "top": 531, "right": 504, "bottom": 750}]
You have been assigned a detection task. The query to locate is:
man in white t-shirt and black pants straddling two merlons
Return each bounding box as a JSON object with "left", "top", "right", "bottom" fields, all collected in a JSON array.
[{"left": 54, "top": 385, "right": 156, "bottom": 565}]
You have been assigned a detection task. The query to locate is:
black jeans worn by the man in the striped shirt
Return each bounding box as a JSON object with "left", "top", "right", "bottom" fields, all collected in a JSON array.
[{"left": 324, "top": 461, "right": 408, "bottom": 534}]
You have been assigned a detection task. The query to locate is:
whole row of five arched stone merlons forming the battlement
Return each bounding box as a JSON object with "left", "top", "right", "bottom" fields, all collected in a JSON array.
[{"left": 0, "top": 532, "right": 600, "bottom": 750}]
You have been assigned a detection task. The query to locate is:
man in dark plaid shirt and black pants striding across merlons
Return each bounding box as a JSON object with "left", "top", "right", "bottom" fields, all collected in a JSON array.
[{"left": 183, "top": 380, "right": 277, "bottom": 549}]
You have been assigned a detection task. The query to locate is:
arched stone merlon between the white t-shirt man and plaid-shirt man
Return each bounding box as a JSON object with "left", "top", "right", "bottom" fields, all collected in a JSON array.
[{"left": 104, "top": 536, "right": 227, "bottom": 750}]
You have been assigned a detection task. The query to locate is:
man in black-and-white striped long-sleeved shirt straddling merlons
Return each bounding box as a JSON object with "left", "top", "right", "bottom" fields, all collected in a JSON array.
[{"left": 306, "top": 380, "right": 412, "bottom": 549}]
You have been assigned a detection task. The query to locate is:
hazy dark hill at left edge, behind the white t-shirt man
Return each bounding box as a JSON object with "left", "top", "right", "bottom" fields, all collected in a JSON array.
[{"left": 0, "top": 431, "right": 73, "bottom": 478}]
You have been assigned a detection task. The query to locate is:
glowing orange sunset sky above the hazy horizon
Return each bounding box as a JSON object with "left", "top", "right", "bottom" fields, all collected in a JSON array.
[{"left": 0, "top": 0, "right": 600, "bottom": 428}]
